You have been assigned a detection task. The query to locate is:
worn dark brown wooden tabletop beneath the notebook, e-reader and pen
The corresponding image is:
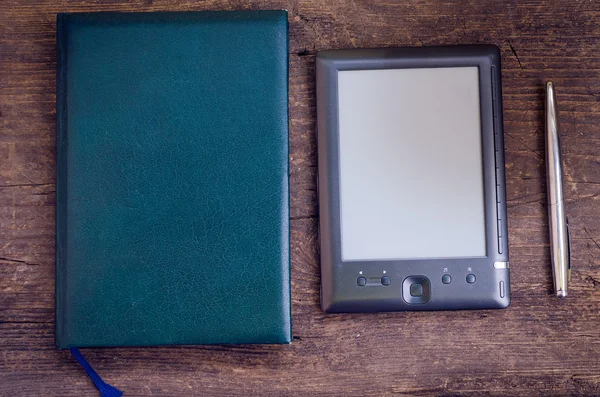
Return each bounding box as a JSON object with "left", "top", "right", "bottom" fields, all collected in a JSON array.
[{"left": 0, "top": 0, "right": 600, "bottom": 396}]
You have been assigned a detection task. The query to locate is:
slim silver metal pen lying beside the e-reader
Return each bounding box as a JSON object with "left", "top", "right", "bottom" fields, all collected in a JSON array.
[{"left": 546, "top": 82, "right": 571, "bottom": 298}]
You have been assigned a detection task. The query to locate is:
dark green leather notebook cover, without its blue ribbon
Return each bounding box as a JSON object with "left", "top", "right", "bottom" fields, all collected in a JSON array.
[{"left": 56, "top": 11, "right": 291, "bottom": 348}]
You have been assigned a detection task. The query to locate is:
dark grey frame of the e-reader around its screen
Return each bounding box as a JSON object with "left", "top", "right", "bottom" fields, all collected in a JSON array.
[{"left": 315, "top": 45, "right": 510, "bottom": 312}]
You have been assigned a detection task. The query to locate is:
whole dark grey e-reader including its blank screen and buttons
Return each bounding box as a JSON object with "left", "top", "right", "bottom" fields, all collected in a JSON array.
[{"left": 316, "top": 45, "right": 510, "bottom": 312}]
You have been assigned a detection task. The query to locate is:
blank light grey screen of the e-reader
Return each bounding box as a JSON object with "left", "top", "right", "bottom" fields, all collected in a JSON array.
[{"left": 338, "top": 67, "right": 486, "bottom": 261}]
